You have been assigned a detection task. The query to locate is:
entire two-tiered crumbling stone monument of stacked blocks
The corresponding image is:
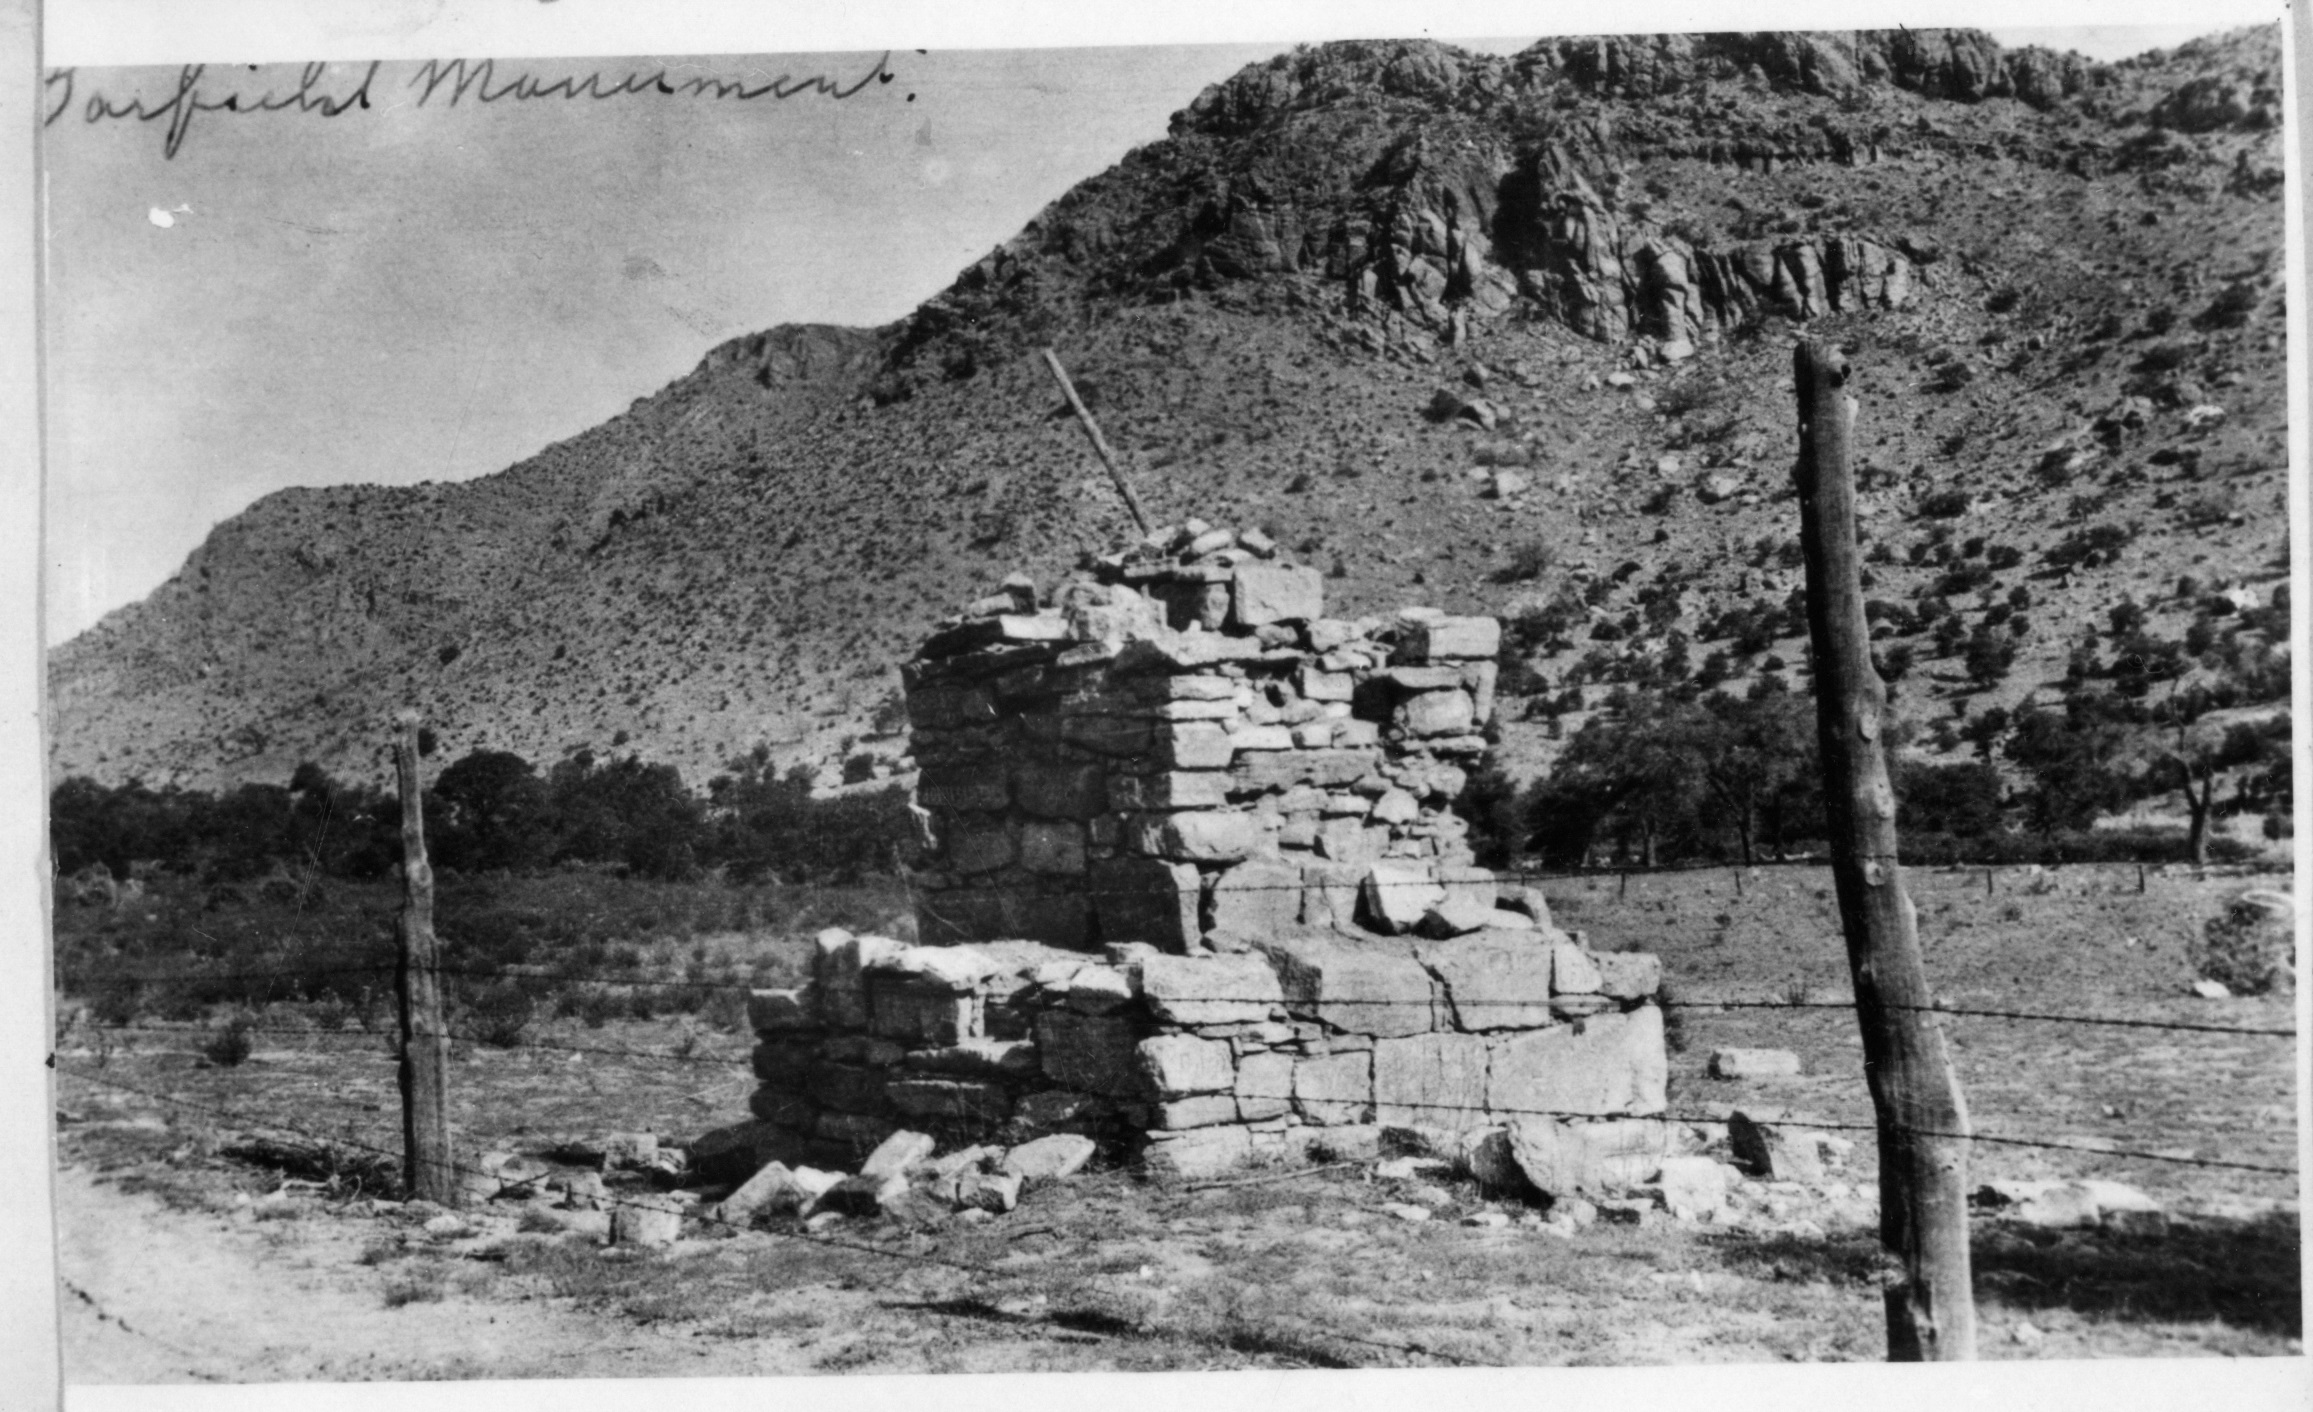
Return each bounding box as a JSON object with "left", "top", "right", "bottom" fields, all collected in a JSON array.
[{"left": 752, "top": 521, "right": 1668, "bottom": 1175}]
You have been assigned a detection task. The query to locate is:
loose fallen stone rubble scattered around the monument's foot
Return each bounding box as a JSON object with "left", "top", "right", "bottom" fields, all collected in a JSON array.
[{"left": 316, "top": 1111, "right": 2211, "bottom": 1255}]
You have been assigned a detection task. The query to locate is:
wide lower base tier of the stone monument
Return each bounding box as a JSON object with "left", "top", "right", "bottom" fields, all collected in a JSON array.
[{"left": 749, "top": 916, "right": 1665, "bottom": 1176}]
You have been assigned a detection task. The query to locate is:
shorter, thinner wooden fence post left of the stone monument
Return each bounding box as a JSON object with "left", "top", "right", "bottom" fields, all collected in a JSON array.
[{"left": 393, "top": 711, "right": 458, "bottom": 1206}]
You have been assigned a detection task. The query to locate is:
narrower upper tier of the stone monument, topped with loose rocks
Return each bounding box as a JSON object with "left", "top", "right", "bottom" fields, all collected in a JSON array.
[{"left": 902, "top": 521, "right": 1501, "bottom": 954}]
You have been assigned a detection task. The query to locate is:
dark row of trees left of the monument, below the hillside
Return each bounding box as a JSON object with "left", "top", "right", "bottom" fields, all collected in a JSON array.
[{"left": 49, "top": 748, "right": 914, "bottom": 882}]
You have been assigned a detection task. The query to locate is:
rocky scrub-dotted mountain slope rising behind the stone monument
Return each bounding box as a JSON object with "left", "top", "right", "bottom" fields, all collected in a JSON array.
[{"left": 51, "top": 30, "right": 2288, "bottom": 785}]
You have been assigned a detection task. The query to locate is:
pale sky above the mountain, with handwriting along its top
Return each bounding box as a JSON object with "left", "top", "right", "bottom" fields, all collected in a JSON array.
[{"left": 31, "top": 25, "right": 2238, "bottom": 641}]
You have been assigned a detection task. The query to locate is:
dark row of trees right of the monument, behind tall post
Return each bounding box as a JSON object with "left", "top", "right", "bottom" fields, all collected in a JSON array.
[{"left": 1462, "top": 674, "right": 2294, "bottom": 868}]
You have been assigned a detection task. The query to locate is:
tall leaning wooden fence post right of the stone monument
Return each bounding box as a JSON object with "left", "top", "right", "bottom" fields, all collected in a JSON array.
[{"left": 1793, "top": 340, "right": 1975, "bottom": 1361}]
